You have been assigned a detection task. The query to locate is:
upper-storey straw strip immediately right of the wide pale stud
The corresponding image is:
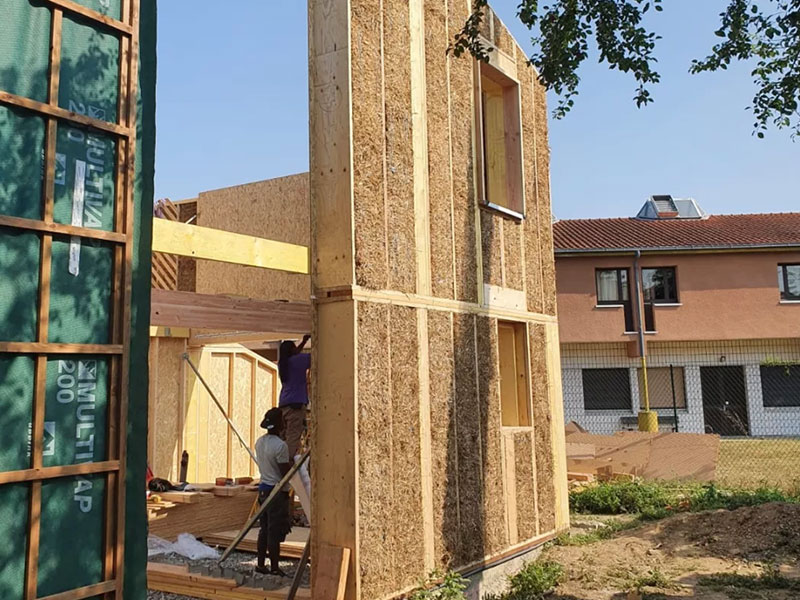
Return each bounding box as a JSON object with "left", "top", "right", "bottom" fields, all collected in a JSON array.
[{"left": 425, "top": 0, "right": 453, "bottom": 298}]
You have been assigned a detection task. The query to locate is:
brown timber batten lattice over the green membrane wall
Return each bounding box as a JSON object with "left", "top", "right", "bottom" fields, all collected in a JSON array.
[{"left": 0, "top": 0, "right": 139, "bottom": 600}]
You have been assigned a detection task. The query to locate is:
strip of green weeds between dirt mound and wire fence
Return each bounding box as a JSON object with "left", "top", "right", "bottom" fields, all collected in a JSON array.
[{"left": 569, "top": 481, "right": 800, "bottom": 516}]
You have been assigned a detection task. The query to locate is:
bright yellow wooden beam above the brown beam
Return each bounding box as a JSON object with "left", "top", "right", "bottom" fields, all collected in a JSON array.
[{"left": 153, "top": 219, "right": 309, "bottom": 273}]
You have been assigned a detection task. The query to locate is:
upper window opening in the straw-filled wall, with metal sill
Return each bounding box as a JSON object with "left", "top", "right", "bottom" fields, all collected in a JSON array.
[{"left": 475, "top": 61, "right": 525, "bottom": 217}]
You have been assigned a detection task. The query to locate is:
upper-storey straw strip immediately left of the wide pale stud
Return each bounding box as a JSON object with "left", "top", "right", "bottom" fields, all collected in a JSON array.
[{"left": 382, "top": 2, "right": 417, "bottom": 293}]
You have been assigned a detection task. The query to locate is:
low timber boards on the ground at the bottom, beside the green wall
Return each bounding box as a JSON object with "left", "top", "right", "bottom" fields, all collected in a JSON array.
[{"left": 147, "top": 562, "right": 311, "bottom": 600}]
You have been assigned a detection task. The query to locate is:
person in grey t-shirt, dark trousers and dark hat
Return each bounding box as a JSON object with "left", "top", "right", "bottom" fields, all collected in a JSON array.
[{"left": 256, "top": 408, "right": 292, "bottom": 577}]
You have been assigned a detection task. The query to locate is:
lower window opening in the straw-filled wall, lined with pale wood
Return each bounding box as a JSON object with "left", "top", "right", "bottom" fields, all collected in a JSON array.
[{"left": 497, "top": 321, "right": 531, "bottom": 427}]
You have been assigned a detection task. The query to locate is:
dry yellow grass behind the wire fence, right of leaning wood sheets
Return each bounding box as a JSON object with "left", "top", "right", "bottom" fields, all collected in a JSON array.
[{"left": 717, "top": 438, "right": 800, "bottom": 491}]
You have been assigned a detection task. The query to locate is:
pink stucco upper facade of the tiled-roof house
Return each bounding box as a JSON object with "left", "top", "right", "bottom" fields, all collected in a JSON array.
[{"left": 556, "top": 252, "right": 800, "bottom": 343}]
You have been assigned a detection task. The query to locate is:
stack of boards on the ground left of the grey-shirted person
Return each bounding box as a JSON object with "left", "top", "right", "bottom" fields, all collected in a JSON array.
[{"left": 147, "top": 486, "right": 257, "bottom": 541}]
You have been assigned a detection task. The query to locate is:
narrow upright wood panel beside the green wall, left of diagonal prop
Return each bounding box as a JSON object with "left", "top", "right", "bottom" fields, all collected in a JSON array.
[{"left": 150, "top": 338, "right": 184, "bottom": 479}]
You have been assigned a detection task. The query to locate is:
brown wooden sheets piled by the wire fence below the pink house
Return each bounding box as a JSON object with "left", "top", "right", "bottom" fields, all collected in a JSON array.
[{"left": 566, "top": 424, "right": 719, "bottom": 481}]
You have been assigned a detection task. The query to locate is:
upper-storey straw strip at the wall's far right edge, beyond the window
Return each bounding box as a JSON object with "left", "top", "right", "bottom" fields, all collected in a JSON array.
[{"left": 534, "top": 82, "right": 556, "bottom": 315}]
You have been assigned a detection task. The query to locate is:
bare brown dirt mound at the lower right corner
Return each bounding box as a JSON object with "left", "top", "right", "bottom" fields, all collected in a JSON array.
[{"left": 544, "top": 503, "right": 800, "bottom": 600}]
